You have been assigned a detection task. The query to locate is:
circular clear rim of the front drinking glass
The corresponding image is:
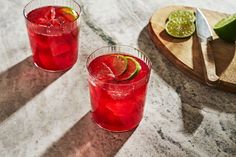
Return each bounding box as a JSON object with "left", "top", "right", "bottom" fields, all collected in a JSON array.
[{"left": 86, "top": 45, "right": 152, "bottom": 86}]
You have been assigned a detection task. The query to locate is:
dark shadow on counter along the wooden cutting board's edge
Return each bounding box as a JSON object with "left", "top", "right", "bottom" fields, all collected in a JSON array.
[{"left": 138, "top": 26, "right": 236, "bottom": 133}]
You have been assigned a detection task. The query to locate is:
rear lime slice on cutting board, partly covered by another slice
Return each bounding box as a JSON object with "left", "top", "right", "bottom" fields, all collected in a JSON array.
[{"left": 168, "top": 10, "right": 196, "bottom": 22}]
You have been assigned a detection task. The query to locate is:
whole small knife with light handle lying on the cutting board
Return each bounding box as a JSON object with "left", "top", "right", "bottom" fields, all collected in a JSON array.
[{"left": 196, "top": 8, "right": 219, "bottom": 85}]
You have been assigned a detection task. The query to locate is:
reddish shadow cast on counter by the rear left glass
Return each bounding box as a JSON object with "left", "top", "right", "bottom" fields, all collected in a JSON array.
[{"left": 0, "top": 57, "right": 64, "bottom": 122}]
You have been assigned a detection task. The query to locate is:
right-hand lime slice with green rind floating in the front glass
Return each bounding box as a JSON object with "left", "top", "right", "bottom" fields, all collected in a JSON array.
[{"left": 116, "top": 56, "right": 141, "bottom": 81}]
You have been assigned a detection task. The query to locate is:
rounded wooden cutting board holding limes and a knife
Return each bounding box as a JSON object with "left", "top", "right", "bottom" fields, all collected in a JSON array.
[{"left": 148, "top": 6, "right": 236, "bottom": 93}]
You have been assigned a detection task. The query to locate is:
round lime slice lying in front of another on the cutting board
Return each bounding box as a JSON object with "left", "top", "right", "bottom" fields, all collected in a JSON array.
[{"left": 165, "top": 20, "right": 195, "bottom": 38}]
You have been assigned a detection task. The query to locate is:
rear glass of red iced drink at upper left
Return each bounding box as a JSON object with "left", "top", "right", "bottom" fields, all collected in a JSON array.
[{"left": 23, "top": 0, "right": 81, "bottom": 72}]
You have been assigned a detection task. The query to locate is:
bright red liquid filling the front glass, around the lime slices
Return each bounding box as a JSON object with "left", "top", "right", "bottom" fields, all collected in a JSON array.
[{"left": 88, "top": 55, "right": 150, "bottom": 131}]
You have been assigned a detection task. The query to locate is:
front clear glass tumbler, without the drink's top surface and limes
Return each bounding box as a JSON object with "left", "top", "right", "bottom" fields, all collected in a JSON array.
[{"left": 87, "top": 45, "right": 151, "bottom": 132}]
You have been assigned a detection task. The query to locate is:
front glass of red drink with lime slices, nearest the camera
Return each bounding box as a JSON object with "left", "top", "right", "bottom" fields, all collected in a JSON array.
[{"left": 87, "top": 45, "right": 151, "bottom": 132}]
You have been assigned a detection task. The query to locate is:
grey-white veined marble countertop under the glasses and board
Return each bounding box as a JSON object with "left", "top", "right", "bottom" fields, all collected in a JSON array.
[{"left": 0, "top": 0, "right": 236, "bottom": 157}]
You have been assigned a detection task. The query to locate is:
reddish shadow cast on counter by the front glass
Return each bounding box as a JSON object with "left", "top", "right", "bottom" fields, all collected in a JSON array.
[{"left": 41, "top": 112, "right": 134, "bottom": 157}]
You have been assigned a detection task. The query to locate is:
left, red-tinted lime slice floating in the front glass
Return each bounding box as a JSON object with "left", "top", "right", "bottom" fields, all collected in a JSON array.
[{"left": 106, "top": 55, "right": 128, "bottom": 76}]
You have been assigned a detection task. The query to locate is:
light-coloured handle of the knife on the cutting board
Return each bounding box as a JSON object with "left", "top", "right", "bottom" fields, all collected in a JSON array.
[{"left": 201, "top": 42, "right": 219, "bottom": 85}]
